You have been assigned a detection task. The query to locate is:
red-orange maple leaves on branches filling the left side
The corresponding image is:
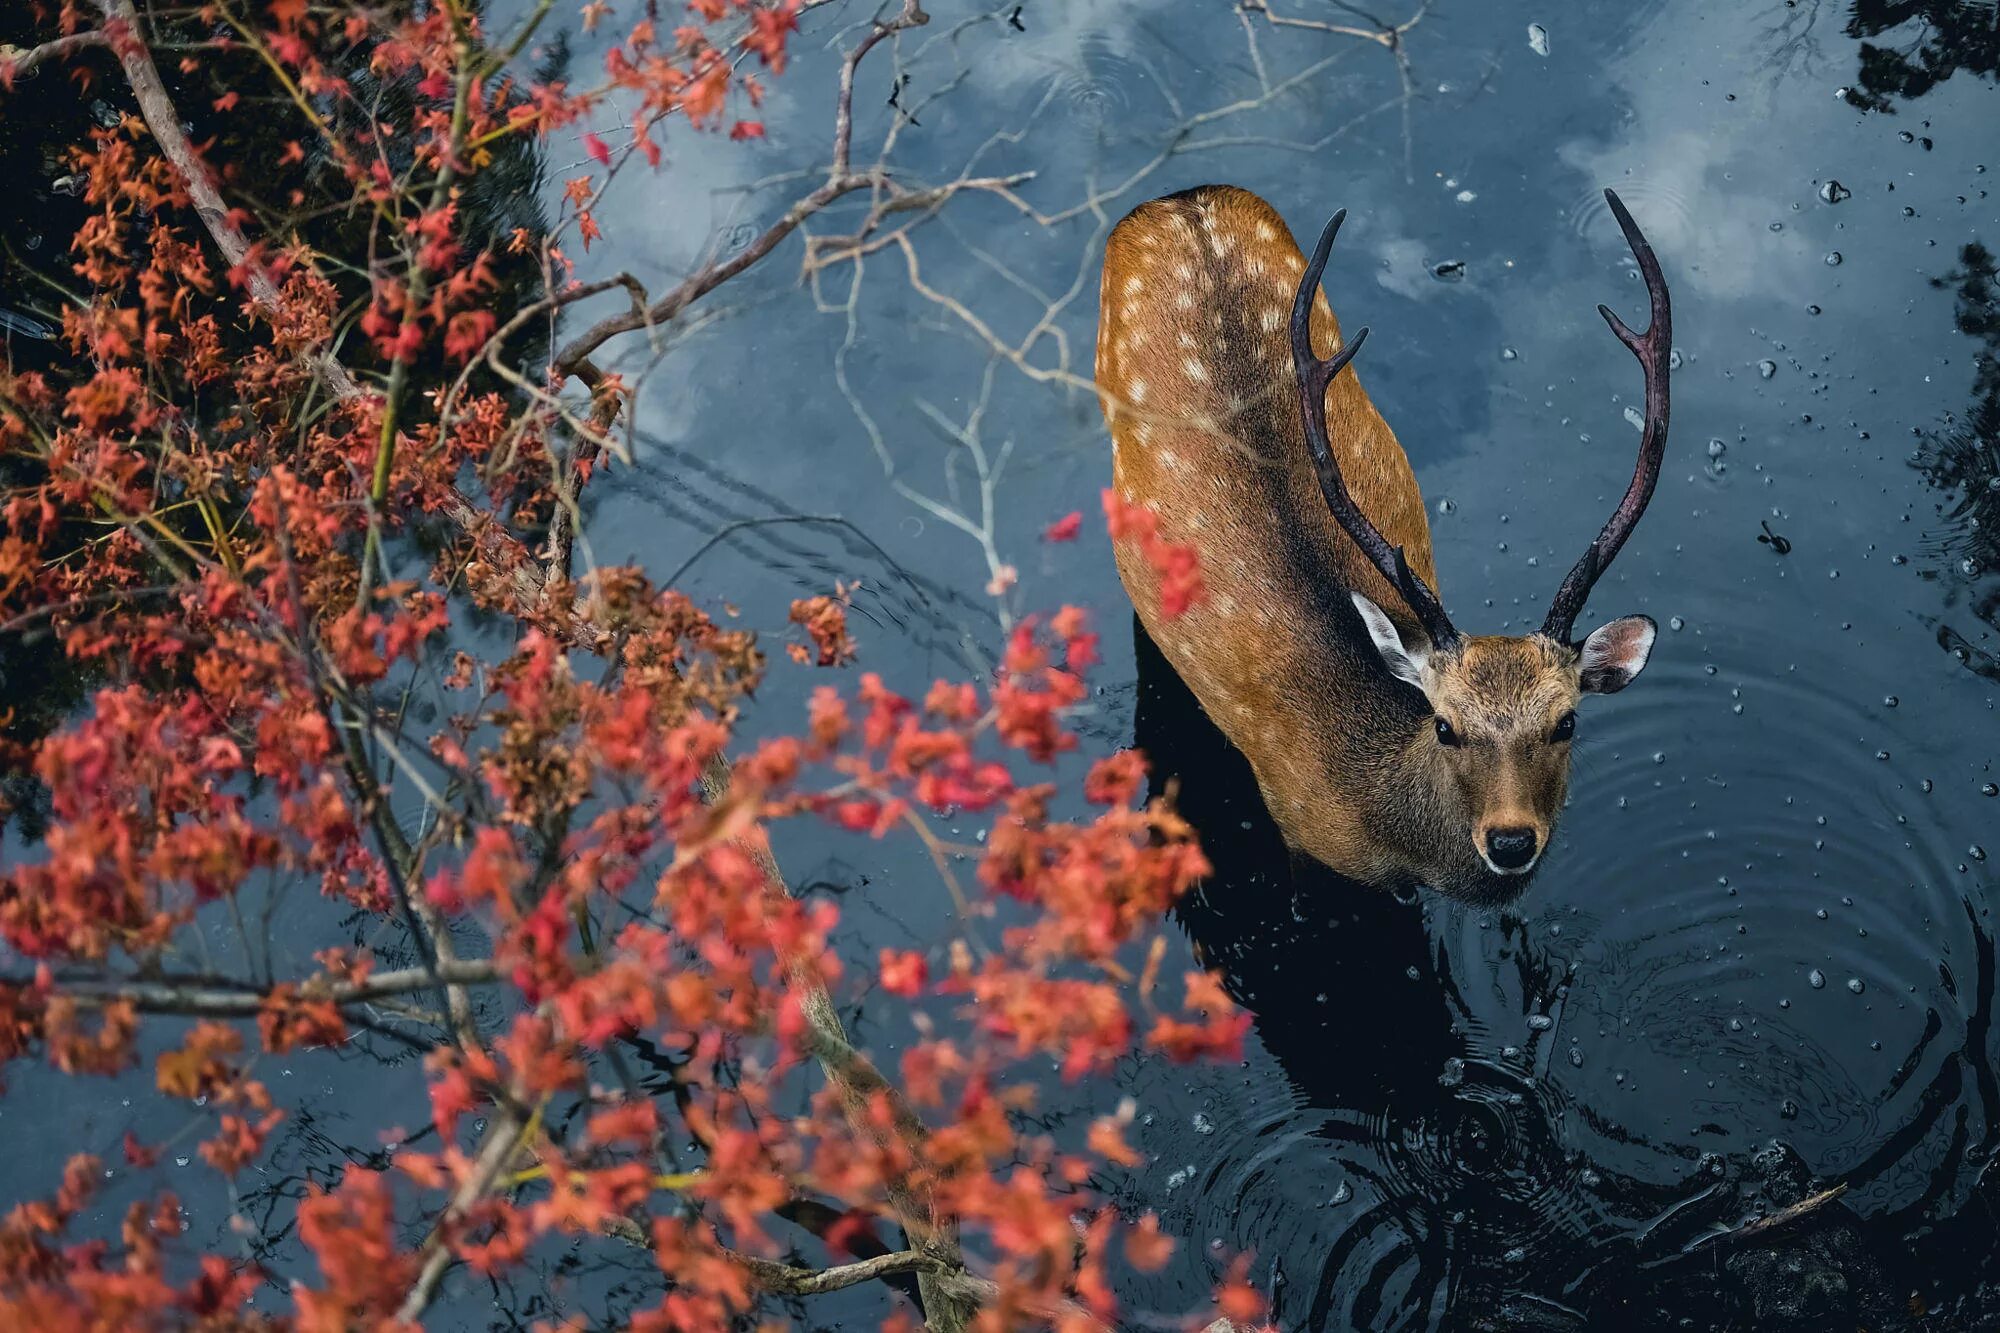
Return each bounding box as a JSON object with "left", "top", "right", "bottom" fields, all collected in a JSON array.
[{"left": 0, "top": 0, "right": 1248, "bottom": 1329}]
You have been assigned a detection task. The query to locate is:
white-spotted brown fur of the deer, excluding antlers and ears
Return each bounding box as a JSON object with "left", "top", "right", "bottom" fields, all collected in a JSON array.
[{"left": 1096, "top": 186, "right": 1578, "bottom": 901}]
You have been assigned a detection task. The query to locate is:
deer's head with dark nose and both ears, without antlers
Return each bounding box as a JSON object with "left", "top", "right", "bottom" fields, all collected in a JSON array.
[{"left": 1354, "top": 592, "right": 1656, "bottom": 901}]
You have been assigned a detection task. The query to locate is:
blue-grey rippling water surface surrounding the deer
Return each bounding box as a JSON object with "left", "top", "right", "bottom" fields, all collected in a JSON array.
[{"left": 11, "top": 0, "right": 2000, "bottom": 1329}]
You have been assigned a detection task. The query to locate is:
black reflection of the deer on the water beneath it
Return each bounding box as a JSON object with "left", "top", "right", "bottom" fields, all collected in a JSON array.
[{"left": 1134, "top": 622, "right": 1920, "bottom": 1329}]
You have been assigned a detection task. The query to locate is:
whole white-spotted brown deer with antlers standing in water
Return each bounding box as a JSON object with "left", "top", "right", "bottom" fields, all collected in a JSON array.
[{"left": 1096, "top": 186, "right": 1672, "bottom": 907}]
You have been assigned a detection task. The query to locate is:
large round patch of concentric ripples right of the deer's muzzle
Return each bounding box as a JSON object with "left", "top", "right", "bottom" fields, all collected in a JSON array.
[{"left": 1504, "top": 656, "right": 1984, "bottom": 1207}]
